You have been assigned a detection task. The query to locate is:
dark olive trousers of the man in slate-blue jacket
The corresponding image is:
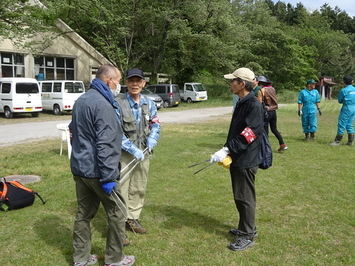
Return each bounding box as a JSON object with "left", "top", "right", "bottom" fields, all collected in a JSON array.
[{"left": 73, "top": 176, "right": 125, "bottom": 263}]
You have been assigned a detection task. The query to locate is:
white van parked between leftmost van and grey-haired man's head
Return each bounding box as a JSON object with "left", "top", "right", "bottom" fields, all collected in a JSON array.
[{"left": 38, "top": 80, "right": 85, "bottom": 115}]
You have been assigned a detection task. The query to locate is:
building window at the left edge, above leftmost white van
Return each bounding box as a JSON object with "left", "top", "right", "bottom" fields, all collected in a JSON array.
[{"left": 0, "top": 53, "right": 25, "bottom": 78}]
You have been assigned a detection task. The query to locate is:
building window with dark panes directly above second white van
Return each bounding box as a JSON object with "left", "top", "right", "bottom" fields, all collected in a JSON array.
[{"left": 35, "top": 56, "right": 75, "bottom": 80}]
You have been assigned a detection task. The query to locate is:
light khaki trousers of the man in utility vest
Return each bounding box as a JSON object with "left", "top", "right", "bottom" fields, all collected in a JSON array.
[{"left": 120, "top": 151, "right": 151, "bottom": 219}]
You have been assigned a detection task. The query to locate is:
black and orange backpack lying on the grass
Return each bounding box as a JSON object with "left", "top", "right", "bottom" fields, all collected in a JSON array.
[{"left": 0, "top": 178, "right": 46, "bottom": 211}]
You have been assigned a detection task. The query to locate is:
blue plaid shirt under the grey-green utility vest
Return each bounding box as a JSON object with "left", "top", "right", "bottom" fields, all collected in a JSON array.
[{"left": 115, "top": 93, "right": 161, "bottom": 153}]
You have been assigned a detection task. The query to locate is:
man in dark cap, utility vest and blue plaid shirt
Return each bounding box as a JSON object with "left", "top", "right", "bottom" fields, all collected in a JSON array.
[{"left": 115, "top": 68, "right": 160, "bottom": 234}]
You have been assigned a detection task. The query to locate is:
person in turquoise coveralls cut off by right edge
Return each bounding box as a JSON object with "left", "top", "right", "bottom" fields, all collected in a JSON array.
[{"left": 329, "top": 76, "right": 355, "bottom": 146}]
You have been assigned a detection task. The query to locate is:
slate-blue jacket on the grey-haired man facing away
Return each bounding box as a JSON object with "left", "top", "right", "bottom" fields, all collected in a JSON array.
[{"left": 69, "top": 81, "right": 123, "bottom": 182}]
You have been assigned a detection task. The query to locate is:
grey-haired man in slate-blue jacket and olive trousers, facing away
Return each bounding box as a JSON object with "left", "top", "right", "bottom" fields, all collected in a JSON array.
[{"left": 69, "top": 64, "right": 135, "bottom": 266}]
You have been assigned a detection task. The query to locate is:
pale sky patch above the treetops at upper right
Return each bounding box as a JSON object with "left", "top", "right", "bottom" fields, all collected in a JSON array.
[{"left": 273, "top": 0, "right": 355, "bottom": 17}]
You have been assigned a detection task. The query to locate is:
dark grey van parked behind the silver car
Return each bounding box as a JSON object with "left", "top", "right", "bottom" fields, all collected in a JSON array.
[{"left": 147, "top": 84, "right": 181, "bottom": 108}]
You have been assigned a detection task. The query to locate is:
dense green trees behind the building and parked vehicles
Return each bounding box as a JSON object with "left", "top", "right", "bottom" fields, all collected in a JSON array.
[{"left": 0, "top": 0, "right": 355, "bottom": 94}]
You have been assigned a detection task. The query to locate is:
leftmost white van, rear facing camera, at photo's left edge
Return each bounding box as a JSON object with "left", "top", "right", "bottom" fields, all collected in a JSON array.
[{"left": 0, "top": 78, "right": 42, "bottom": 118}]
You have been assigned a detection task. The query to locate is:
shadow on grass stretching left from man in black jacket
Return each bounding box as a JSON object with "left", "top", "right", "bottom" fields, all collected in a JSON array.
[{"left": 144, "top": 204, "right": 238, "bottom": 239}]
